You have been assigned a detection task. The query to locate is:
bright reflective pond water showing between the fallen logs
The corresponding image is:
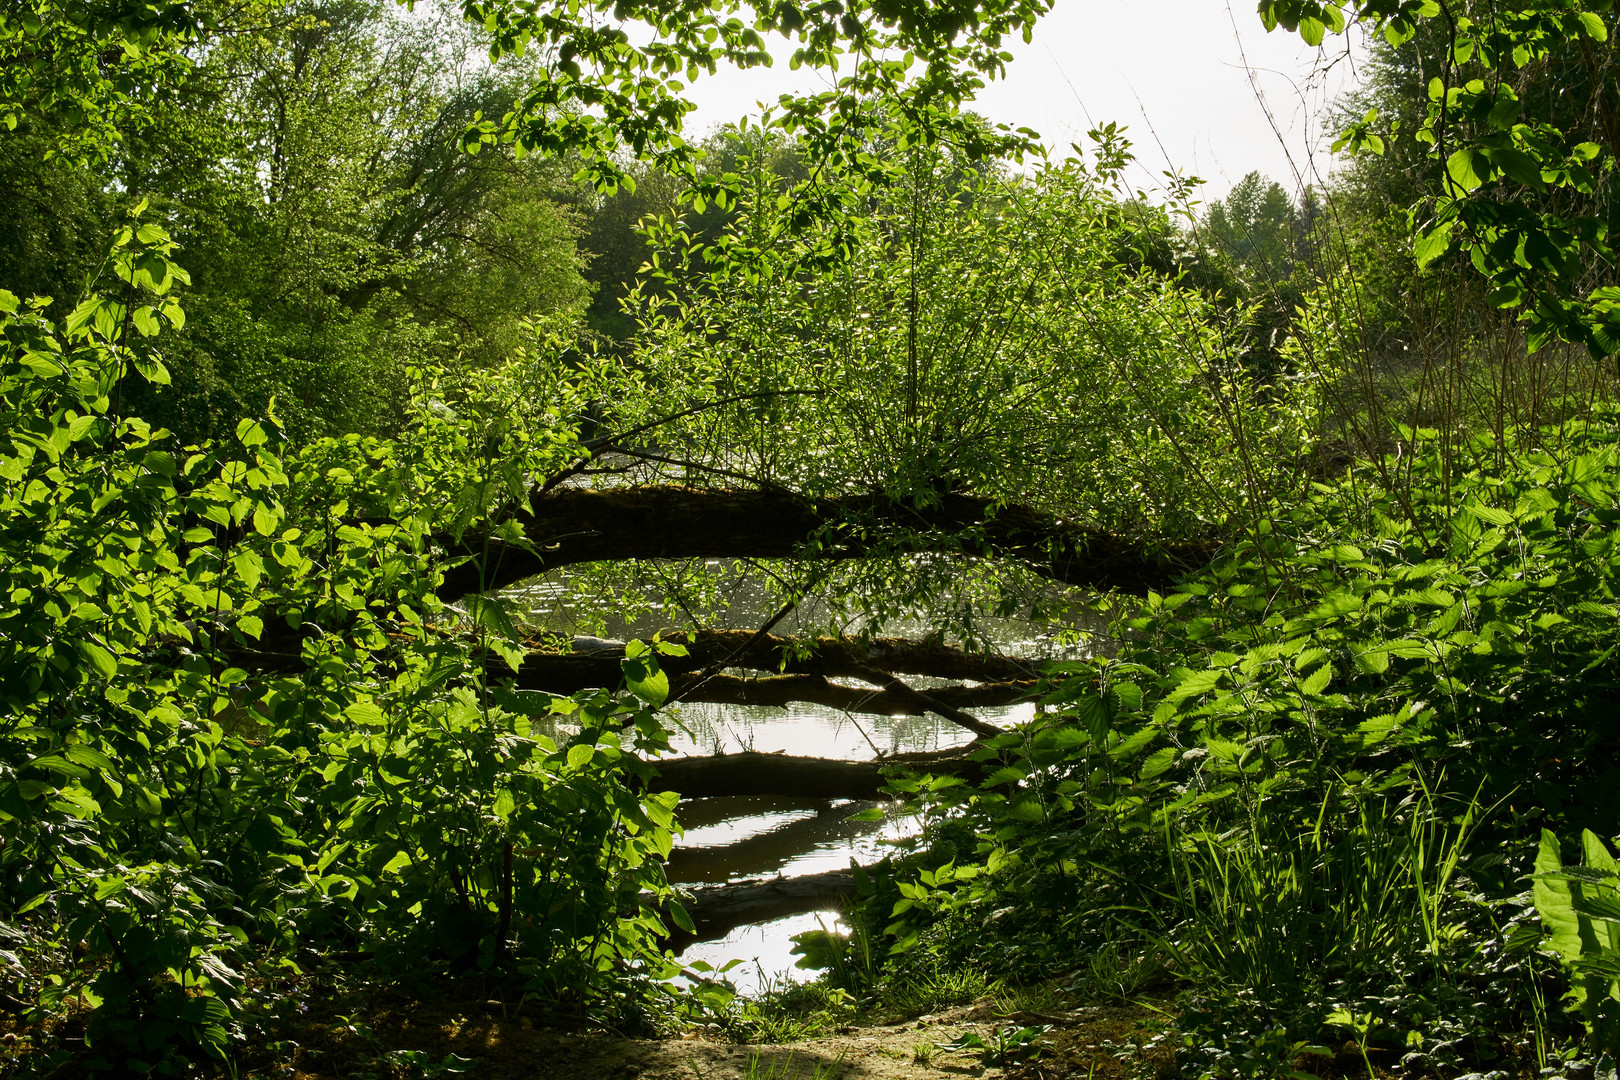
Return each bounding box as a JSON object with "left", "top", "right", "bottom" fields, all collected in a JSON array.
[{"left": 505, "top": 575, "right": 1097, "bottom": 994}]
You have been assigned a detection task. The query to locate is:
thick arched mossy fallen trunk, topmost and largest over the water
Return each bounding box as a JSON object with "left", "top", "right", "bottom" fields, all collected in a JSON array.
[{"left": 437, "top": 486, "right": 1215, "bottom": 599}]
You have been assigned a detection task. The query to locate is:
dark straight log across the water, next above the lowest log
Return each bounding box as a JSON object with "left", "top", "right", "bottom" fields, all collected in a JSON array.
[{"left": 650, "top": 746, "right": 983, "bottom": 798}]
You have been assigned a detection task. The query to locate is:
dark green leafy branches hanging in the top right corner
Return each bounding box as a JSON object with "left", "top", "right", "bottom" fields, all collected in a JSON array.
[{"left": 1260, "top": 0, "right": 1620, "bottom": 356}]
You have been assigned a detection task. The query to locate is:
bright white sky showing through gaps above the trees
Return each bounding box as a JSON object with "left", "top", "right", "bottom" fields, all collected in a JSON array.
[{"left": 673, "top": 0, "right": 1354, "bottom": 199}]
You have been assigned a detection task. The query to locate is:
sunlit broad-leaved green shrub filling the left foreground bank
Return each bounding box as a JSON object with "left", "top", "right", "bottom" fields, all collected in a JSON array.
[{"left": 0, "top": 222, "right": 676, "bottom": 1075}]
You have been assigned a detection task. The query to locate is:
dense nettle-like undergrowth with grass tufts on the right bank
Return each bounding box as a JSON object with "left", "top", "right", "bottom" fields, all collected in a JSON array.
[{"left": 868, "top": 415, "right": 1620, "bottom": 1075}]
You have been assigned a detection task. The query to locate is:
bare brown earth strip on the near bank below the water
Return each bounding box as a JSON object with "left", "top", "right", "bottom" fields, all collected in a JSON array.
[{"left": 221, "top": 986, "right": 1165, "bottom": 1080}]
